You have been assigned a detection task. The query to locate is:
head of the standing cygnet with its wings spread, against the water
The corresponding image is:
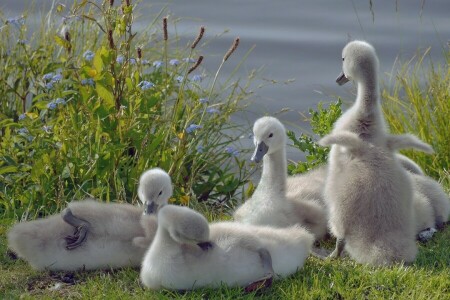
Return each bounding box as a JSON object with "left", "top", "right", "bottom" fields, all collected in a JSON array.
[{"left": 336, "top": 41, "right": 379, "bottom": 85}]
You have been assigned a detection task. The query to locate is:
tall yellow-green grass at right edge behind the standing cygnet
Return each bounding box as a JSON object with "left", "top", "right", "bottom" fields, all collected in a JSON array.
[{"left": 382, "top": 50, "right": 450, "bottom": 186}]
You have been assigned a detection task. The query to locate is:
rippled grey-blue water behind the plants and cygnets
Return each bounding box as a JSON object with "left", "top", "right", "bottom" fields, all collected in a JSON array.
[{"left": 0, "top": 0, "right": 450, "bottom": 156}]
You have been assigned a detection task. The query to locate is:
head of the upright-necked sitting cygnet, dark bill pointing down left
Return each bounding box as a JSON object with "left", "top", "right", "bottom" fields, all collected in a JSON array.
[{"left": 252, "top": 117, "right": 286, "bottom": 163}]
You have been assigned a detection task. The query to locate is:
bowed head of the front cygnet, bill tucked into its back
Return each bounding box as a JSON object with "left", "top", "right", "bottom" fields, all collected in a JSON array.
[{"left": 158, "top": 205, "right": 209, "bottom": 244}]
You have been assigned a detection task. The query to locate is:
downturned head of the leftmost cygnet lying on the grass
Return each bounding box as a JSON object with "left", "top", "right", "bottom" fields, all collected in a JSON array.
[{"left": 138, "top": 168, "right": 173, "bottom": 214}]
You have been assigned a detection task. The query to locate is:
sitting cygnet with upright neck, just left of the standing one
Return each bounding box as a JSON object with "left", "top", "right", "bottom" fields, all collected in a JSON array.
[{"left": 234, "top": 117, "right": 327, "bottom": 239}]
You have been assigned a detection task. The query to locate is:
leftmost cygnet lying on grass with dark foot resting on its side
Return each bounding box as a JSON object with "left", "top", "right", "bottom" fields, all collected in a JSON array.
[{"left": 8, "top": 169, "right": 172, "bottom": 271}]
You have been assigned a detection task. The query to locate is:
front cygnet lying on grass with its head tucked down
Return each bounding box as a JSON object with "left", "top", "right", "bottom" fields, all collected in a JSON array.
[{"left": 140, "top": 205, "right": 314, "bottom": 290}]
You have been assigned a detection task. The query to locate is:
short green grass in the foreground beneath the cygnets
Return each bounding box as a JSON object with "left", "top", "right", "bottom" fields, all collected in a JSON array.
[{"left": 0, "top": 220, "right": 450, "bottom": 300}]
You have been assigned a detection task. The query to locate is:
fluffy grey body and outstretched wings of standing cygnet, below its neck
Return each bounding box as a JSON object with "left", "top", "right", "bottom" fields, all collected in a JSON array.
[{"left": 319, "top": 131, "right": 432, "bottom": 265}]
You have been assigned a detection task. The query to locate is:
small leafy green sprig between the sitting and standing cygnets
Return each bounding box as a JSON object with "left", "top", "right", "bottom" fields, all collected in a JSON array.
[{"left": 287, "top": 99, "right": 342, "bottom": 175}]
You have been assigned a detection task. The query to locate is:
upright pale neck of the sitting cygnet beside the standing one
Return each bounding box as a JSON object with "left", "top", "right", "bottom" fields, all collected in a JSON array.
[{"left": 258, "top": 147, "right": 287, "bottom": 195}]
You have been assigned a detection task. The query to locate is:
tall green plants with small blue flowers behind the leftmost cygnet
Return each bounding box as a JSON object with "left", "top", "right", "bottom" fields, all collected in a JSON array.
[{"left": 0, "top": 1, "right": 250, "bottom": 216}]
